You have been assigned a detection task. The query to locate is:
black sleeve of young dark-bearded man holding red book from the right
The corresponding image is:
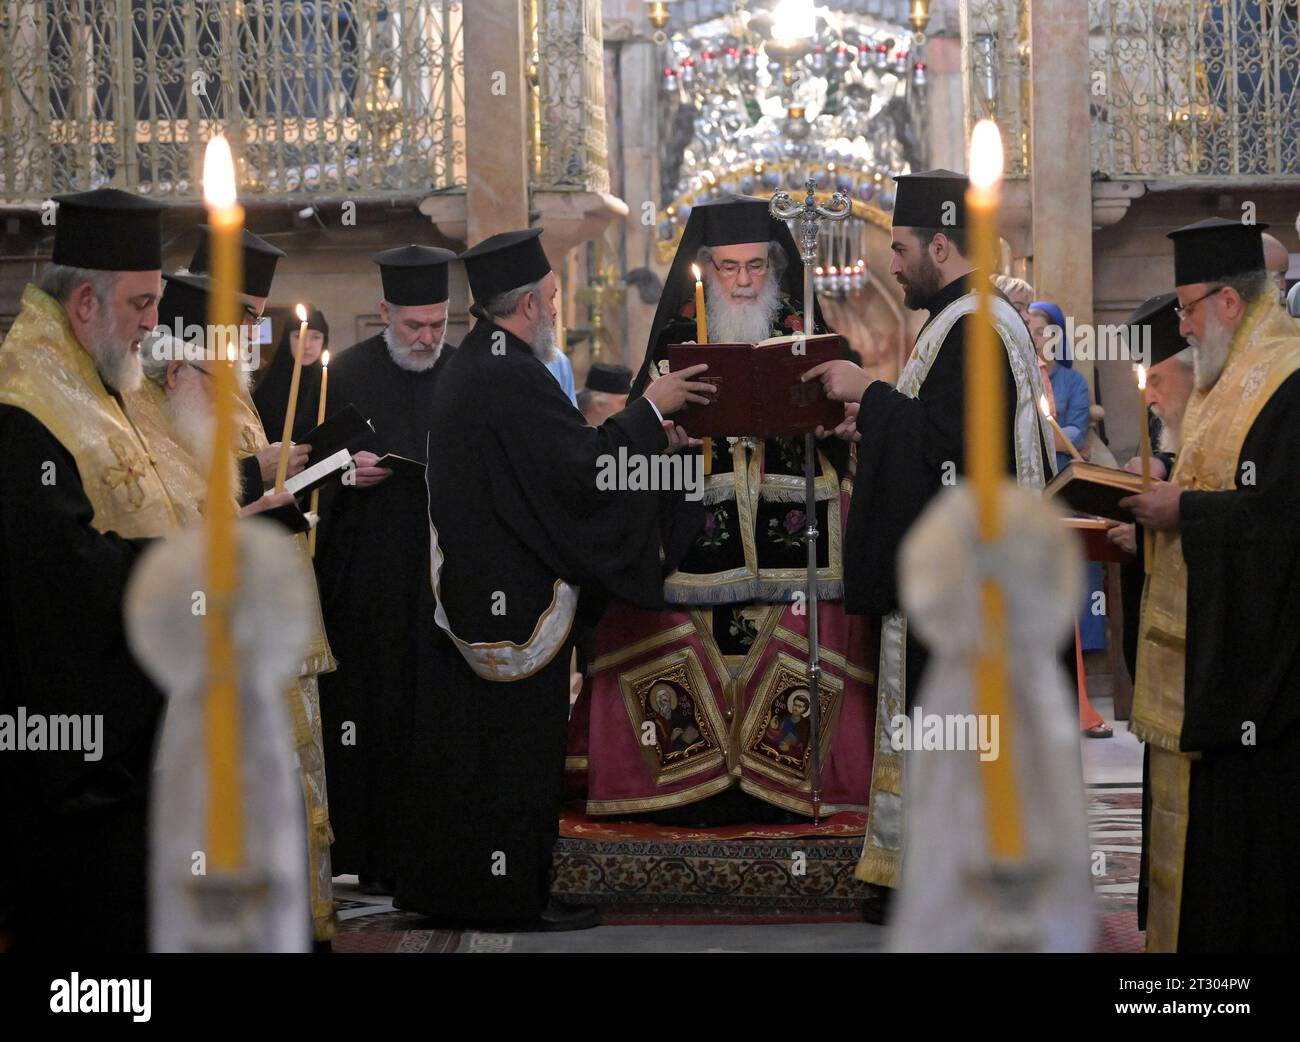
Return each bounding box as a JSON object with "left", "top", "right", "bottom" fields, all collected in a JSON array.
[{"left": 844, "top": 316, "right": 1015, "bottom": 616}]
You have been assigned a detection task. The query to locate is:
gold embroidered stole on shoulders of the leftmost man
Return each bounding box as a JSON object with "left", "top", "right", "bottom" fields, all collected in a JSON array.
[{"left": 0, "top": 286, "right": 179, "bottom": 538}]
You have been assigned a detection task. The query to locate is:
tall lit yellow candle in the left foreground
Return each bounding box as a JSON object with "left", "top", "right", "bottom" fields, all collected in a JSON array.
[{"left": 203, "top": 136, "right": 243, "bottom": 870}]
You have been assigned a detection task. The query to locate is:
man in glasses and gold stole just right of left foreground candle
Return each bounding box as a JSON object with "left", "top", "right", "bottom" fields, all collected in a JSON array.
[{"left": 178, "top": 225, "right": 315, "bottom": 503}]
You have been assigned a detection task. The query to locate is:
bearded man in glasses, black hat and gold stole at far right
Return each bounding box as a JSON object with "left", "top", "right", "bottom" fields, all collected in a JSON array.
[{"left": 1121, "top": 218, "right": 1300, "bottom": 952}]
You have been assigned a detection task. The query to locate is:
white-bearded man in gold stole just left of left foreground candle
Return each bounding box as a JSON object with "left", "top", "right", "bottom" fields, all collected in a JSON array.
[{"left": 124, "top": 274, "right": 334, "bottom": 947}]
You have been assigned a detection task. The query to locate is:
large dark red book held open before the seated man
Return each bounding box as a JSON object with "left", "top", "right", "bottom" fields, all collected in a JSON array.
[{"left": 668, "top": 333, "right": 845, "bottom": 438}]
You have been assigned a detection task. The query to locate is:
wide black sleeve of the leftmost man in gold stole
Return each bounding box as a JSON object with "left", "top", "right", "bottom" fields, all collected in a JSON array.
[{"left": 0, "top": 407, "right": 163, "bottom": 812}]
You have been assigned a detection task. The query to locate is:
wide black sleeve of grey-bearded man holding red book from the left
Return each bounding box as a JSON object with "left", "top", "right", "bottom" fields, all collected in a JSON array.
[{"left": 489, "top": 366, "right": 667, "bottom": 607}]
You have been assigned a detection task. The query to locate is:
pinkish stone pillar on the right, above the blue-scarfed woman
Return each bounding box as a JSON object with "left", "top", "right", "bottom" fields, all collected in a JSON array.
[{"left": 1030, "top": 0, "right": 1092, "bottom": 386}]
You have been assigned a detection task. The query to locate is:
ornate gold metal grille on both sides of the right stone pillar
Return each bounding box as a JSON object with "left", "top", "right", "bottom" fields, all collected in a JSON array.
[{"left": 962, "top": 0, "right": 1300, "bottom": 179}]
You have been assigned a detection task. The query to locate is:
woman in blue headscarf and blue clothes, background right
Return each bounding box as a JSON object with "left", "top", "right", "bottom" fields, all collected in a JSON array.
[{"left": 1026, "top": 300, "right": 1112, "bottom": 738}]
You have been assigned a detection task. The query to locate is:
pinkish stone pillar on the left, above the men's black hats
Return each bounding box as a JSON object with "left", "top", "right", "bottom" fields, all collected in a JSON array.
[{"left": 464, "top": 3, "right": 529, "bottom": 244}]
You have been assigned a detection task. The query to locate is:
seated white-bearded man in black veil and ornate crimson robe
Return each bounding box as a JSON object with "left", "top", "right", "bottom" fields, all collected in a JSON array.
[{"left": 569, "top": 195, "right": 875, "bottom": 825}]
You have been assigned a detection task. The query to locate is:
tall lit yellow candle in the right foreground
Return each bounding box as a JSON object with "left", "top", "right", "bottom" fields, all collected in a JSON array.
[{"left": 966, "top": 120, "right": 1026, "bottom": 861}]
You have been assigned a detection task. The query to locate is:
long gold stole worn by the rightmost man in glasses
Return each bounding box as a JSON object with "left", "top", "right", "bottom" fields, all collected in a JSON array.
[{"left": 1128, "top": 299, "right": 1300, "bottom": 951}]
